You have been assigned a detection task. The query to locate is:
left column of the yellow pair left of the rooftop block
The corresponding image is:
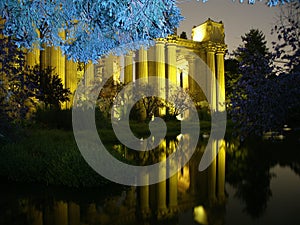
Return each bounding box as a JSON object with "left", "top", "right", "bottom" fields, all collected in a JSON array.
[{"left": 155, "top": 39, "right": 166, "bottom": 116}]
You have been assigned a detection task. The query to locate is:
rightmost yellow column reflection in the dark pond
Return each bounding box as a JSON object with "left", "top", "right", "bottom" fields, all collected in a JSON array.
[{"left": 217, "top": 140, "right": 226, "bottom": 201}]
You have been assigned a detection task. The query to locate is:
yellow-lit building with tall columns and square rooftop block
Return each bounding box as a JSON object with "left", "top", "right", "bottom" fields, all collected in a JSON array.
[{"left": 27, "top": 19, "right": 226, "bottom": 111}]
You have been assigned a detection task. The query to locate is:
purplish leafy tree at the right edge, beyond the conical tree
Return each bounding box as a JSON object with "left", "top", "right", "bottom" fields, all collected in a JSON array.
[{"left": 273, "top": 1, "right": 300, "bottom": 126}]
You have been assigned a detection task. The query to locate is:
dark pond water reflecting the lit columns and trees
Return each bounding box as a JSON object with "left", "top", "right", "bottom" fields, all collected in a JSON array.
[{"left": 0, "top": 135, "right": 300, "bottom": 225}]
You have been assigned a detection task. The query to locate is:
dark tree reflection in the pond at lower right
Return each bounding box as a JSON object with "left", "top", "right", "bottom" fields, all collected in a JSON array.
[{"left": 226, "top": 135, "right": 300, "bottom": 219}]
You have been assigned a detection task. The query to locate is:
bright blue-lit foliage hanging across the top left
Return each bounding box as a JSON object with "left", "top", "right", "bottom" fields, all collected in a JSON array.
[{"left": 0, "top": 0, "right": 299, "bottom": 62}]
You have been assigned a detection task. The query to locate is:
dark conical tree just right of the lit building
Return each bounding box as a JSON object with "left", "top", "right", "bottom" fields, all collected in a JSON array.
[{"left": 231, "top": 29, "right": 284, "bottom": 137}]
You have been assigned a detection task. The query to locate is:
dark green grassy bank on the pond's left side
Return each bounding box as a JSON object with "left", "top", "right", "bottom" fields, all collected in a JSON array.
[{"left": 0, "top": 129, "right": 108, "bottom": 187}]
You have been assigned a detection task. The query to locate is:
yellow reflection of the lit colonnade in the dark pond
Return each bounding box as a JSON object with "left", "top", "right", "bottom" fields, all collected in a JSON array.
[{"left": 0, "top": 137, "right": 225, "bottom": 225}]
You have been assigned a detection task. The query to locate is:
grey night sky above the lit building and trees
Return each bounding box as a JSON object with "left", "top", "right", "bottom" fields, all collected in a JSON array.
[{"left": 177, "top": 0, "right": 280, "bottom": 52}]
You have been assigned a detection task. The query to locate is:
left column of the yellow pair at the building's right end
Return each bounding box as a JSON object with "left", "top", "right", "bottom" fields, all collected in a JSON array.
[{"left": 206, "top": 46, "right": 217, "bottom": 111}]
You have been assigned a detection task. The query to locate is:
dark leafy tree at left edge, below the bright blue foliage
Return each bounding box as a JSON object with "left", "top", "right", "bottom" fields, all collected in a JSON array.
[{"left": 0, "top": 24, "right": 35, "bottom": 121}]
